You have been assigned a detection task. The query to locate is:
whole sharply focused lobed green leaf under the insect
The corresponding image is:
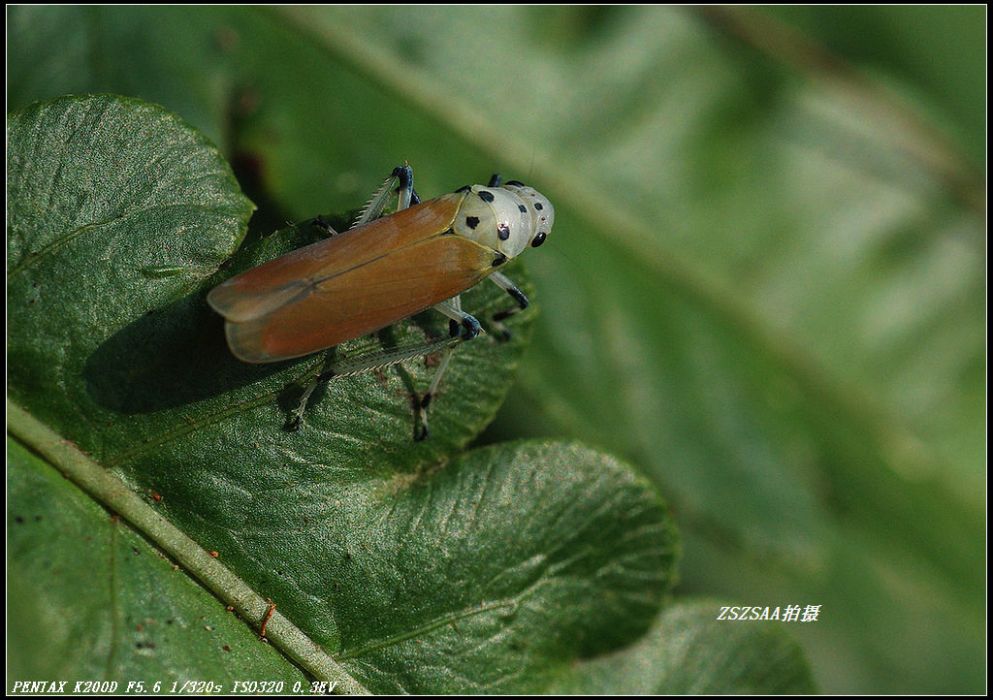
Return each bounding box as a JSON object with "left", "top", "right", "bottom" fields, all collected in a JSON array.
[{"left": 8, "top": 91, "right": 802, "bottom": 693}]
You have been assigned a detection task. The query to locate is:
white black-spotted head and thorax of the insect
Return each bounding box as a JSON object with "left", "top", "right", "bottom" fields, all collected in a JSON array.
[{"left": 453, "top": 180, "right": 555, "bottom": 258}]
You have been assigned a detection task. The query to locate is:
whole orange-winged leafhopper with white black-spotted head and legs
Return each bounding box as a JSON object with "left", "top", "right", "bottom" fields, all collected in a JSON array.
[{"left": 207, "top": 166, "right": 555, "bottom": 432}]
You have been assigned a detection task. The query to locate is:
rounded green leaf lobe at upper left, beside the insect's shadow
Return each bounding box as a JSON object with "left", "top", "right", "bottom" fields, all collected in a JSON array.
[{"left": 7, "top": 96, "right": 254, "bottom": 432}]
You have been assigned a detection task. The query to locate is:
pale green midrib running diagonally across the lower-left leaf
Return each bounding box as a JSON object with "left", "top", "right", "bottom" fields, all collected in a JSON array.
[{"left": 7, "top": 399, "right": 369, "bottom": 695}]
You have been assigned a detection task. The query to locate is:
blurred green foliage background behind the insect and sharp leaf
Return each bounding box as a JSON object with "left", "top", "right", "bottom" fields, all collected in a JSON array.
[{"left": 8, "top": 7, "right": 986, "bottom": 692}]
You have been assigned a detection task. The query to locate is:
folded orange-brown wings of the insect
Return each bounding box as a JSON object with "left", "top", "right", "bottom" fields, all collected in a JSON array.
[{"left": 207, "top": 193, "right": 495, "bottom": 363}]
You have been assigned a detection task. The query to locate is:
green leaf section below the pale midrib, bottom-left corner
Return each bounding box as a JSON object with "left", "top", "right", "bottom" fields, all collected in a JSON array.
[{"left": 7, "top": 439, "right": 309, "bottom": 692}]
